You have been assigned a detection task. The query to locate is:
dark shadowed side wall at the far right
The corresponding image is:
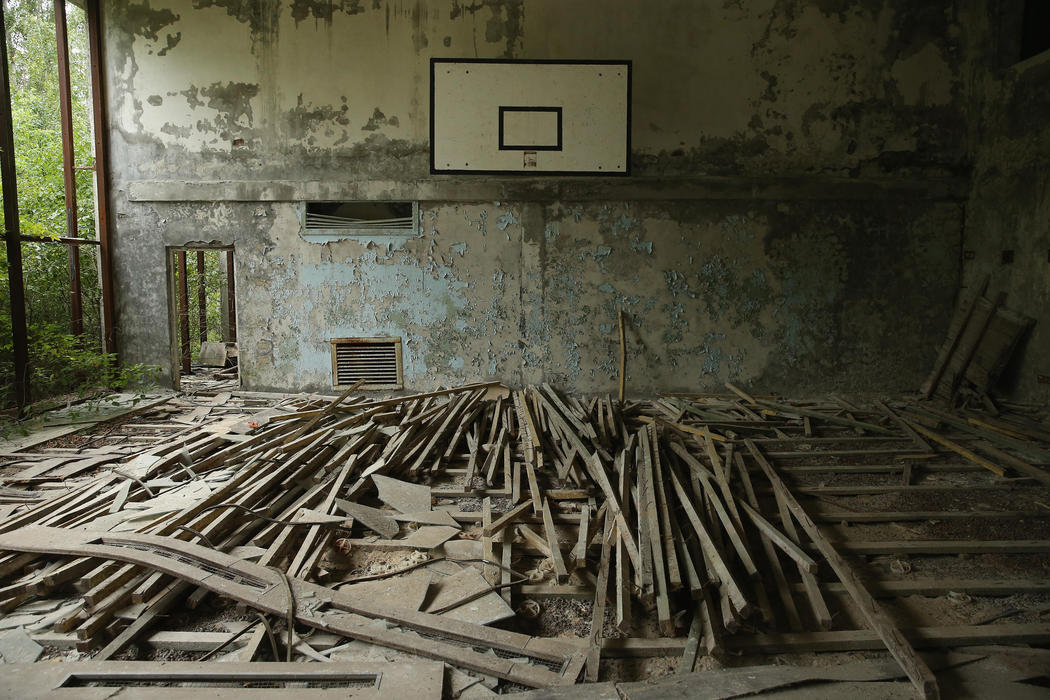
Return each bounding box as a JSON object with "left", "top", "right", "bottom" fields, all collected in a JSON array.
[{"left": 964, "top": 2, "right": 1050, "bottom": 403}]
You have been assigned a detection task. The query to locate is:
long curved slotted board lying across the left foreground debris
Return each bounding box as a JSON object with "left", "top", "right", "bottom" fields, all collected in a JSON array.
[{"left": 0, "top": 527, "right": 585, "bottom": 687}]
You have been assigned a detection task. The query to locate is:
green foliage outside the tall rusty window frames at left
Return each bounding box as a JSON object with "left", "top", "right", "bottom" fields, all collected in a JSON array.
[{"left": 0, "top": 0, "right": 150, "bottom": 408}]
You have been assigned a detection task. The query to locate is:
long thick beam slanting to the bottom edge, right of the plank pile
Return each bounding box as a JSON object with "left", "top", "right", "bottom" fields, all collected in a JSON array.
[{"left": 744, "top": 440, "right": 940, "bottom": 698}]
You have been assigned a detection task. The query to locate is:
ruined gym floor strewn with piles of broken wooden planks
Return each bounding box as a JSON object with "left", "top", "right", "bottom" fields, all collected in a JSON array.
[{"left": 0, "top": 380, "right": 1050, "bottom": 697}]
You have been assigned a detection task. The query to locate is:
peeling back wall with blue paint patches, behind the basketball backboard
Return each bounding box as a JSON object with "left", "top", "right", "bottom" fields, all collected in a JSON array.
[{"left": 105, "top": 0, "right": 969, "bottom": 394}]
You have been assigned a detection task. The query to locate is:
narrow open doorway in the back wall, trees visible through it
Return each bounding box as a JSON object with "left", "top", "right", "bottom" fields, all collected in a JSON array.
[{"left": 166, "top": 246, "right": 240, "bottom": 391}]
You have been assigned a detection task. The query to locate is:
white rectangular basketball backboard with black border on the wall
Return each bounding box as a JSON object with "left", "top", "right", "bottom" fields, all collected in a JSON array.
[{"left": 431, "top": 59, "right": 631, "bottom": 175}]
